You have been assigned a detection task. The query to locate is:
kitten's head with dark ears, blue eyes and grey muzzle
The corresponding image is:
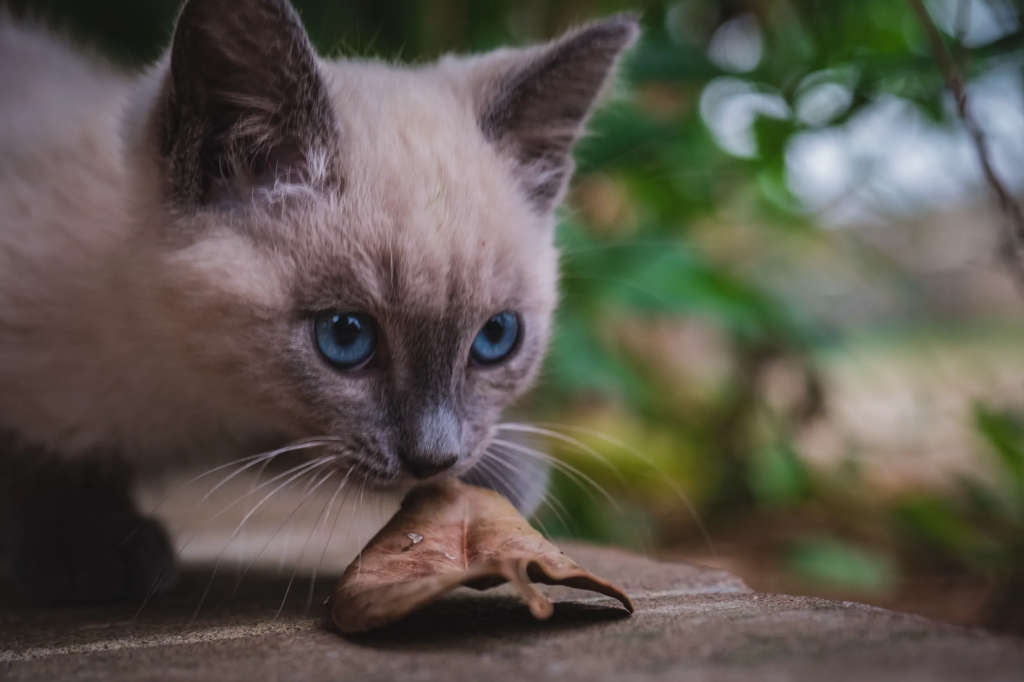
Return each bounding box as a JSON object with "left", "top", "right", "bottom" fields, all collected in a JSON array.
[{"left": 134, "top": 0, "right": 638, "bottom": 486}]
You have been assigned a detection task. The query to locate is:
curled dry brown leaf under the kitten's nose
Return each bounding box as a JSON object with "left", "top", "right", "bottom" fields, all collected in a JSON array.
[{"left": 327, "top": 481, "right": 633, "bottom": 633}]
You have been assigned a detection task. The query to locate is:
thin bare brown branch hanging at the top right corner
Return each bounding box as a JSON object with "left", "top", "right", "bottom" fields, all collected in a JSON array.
[{"left": 907, "top": 0, "right": 1024, "bottom": 293}]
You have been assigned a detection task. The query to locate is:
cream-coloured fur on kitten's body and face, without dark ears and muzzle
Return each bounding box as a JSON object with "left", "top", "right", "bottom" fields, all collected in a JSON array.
[{"left": 0, "top": 7, "right": 634, "bottom": 483}]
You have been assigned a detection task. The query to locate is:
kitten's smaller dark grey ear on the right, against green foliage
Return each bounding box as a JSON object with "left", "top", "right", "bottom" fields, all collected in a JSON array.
[{"left": 475, "top": 14, "right": 640, "bottom": 213}]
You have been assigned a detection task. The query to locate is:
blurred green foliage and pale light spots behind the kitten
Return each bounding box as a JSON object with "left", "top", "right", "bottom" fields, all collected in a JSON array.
[{"left": 9, "top": 0, "right": 1024, "bottom": 626}]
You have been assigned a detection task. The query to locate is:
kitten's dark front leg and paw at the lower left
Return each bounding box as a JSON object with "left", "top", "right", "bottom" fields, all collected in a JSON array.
[{"left": 0, "top": 435, "right": 173, "bottom": 606}]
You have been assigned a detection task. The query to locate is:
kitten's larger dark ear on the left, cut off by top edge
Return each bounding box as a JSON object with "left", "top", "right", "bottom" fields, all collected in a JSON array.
[{"left": 159, "top": 0, "right": 341, "bottom": 205}]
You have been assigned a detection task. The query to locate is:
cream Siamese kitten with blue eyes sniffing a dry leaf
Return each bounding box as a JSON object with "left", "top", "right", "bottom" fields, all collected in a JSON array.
[{"left": 0, "top": 0, "right": 638, "bottom": 603}]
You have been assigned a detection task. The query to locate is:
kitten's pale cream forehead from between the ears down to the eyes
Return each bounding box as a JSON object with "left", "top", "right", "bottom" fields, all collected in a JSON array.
[{"left": 272, "top": 62, "right": 557, "bottom": 311}]
